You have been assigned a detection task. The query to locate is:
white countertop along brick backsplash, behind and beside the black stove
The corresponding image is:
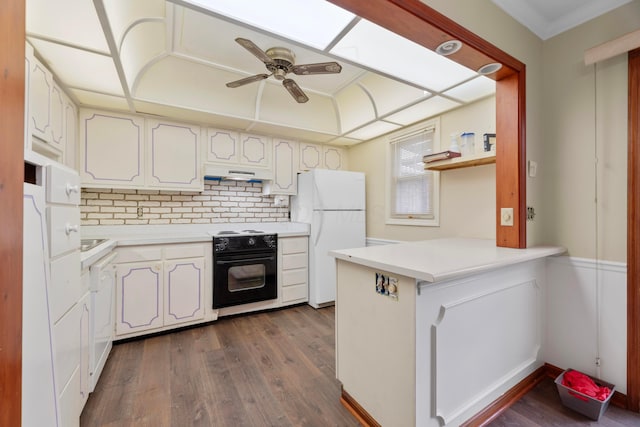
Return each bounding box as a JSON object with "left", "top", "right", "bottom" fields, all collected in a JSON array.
[{"left": 80, "top": 222, "right": 309, "bottom": 269}]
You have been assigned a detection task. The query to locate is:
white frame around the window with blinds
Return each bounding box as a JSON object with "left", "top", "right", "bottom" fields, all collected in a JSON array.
[{"left": 385, "top": 117, "right": 440, "bottom": 227}]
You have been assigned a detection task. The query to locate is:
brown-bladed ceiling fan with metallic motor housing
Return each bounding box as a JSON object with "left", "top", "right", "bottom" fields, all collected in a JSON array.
[{"left": 227, "top": 37, "right": 342, "bottom": 103}]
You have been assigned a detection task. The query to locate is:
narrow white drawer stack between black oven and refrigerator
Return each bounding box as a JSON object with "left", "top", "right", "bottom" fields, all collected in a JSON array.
[{"left": 278, "top": 236, "right": 309, "bottom": 305}]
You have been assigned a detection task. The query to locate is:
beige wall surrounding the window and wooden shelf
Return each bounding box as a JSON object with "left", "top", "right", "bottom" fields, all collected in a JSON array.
[{"left": 349, "top": 97, "right": 496, "bottom": 240}]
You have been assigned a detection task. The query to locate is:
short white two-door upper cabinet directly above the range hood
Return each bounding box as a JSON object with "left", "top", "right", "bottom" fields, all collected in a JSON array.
[{"left": 206, "top": 128, "right": 271, "bottom": 168}]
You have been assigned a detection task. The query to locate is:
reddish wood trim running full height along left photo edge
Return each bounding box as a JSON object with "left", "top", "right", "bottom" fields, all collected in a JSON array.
[{"left": 0, "top": 0, "right": 25, "bottom": 426}]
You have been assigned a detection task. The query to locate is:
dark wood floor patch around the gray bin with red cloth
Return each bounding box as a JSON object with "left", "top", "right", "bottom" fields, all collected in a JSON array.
[{"left": 490, "top": 378, "right": 640, "bottom": 427}]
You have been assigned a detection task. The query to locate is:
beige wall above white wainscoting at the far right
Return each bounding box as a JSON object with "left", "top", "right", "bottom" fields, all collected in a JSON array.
[{"left": 539, "top": 1, "right": 640, "bottom": 262}]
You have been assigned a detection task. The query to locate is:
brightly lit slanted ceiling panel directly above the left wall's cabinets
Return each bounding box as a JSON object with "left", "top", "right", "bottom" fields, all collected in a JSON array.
[{"left": 29, "top": 39, "right": 124, "bottom": 96}]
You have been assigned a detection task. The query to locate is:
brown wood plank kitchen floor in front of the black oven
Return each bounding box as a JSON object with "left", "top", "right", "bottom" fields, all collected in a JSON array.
[{"left": 80, "top": 305, "right": 359, "bottom": 427}]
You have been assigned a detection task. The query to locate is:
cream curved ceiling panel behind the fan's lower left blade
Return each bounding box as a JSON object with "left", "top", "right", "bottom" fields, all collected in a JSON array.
[{"left": 134, "top": 56, "right": 259, "bottom": 118}]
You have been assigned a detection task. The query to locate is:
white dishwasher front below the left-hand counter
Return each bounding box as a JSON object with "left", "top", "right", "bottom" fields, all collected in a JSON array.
[{"left": 89, "top": 252, "right": 117, "bottom": 391}]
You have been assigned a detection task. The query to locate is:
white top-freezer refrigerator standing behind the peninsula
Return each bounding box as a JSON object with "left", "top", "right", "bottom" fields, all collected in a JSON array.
[{"left": 291, "top": 169, "right": 366, "bottom": 308}]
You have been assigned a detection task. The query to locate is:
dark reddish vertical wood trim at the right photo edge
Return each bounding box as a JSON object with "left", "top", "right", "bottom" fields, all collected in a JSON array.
[{"left": 627, "top": 49, "right": 640, "bottom": 412}]
